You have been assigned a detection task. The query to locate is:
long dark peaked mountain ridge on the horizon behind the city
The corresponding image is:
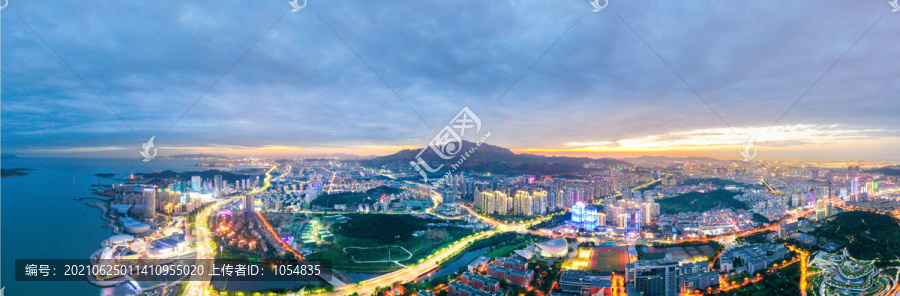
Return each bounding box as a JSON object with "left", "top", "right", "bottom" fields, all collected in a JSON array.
[{"left": 360, "top": 141, "right": 631, "bottom": 175}]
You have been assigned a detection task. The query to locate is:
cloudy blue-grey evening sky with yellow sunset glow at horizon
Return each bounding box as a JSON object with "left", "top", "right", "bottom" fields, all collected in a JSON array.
[{"left": 0, "top": 0, "right": 900, "bottom": 160}]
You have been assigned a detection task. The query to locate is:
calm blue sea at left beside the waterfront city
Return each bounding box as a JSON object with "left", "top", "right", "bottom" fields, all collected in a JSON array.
[{"left": 0, "top": 158, "right": 202, "bottom": 295}]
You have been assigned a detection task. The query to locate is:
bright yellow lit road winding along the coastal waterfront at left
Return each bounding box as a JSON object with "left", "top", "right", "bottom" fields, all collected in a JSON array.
[{"left": 184, "top": 166, "right": 277, "bottom": 296}]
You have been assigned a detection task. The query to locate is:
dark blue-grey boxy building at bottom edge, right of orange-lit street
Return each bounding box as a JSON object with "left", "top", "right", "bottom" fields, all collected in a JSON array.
[{"left": 625, "top": 259, "right": 678, "bottom": 296}]
